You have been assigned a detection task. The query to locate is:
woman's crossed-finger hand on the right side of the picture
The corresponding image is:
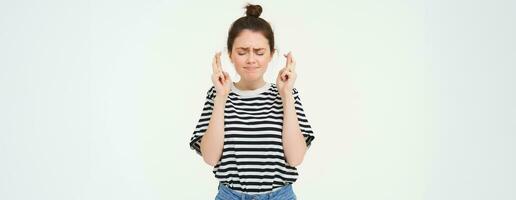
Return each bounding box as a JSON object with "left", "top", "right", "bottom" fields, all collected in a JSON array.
[{"left": 276, "top": 52, "right": 297, "bottom": 97}]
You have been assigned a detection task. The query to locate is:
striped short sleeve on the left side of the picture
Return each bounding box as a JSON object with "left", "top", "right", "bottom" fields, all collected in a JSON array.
[{"left": 190, "top": 86, "right": 215, "bottom": 155}]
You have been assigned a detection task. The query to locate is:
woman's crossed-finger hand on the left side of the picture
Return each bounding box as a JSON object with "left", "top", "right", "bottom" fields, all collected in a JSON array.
[{"left": 211, "top": 52, "right": 233, "bottom": 96}]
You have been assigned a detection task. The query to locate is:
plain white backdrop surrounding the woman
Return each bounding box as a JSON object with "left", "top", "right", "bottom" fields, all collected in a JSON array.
[{"left": 0, "top": 0, "right": 516, "bottom": 200}]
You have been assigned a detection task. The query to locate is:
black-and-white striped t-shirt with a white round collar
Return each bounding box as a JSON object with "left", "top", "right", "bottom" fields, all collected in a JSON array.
[{"left": 190, "top": 83, "right": 314, "bottom": 194}]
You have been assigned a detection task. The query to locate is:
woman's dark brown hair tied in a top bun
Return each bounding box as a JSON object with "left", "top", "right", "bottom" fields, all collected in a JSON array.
[{"left": 228, "top": 4, "right": 274, "bottom": 54}]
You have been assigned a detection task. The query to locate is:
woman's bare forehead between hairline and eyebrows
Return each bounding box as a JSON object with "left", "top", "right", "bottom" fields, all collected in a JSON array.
[{"left": 233, "top": 29, "right": 269, "bottom": 49}]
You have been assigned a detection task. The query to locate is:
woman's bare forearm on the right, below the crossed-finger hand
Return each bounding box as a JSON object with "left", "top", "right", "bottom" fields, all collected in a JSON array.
[{"left": 281, "top": 93, "right": 307, "bottom": 167}]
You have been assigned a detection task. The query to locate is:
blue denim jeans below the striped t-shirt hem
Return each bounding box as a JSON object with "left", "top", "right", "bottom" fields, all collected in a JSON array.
[{"left": 215, "top": 183, "right": 296, "bottom": 200}]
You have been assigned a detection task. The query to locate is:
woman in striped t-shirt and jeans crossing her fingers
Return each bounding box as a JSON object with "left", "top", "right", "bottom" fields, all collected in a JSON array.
[{"left": 190, "top": 5, "right": 314, "bottom": 200}]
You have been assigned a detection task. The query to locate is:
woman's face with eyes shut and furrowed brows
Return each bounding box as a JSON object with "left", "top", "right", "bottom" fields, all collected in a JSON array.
[{"left": 229, "top": 29, "right": 272, "bottom": 81}]
